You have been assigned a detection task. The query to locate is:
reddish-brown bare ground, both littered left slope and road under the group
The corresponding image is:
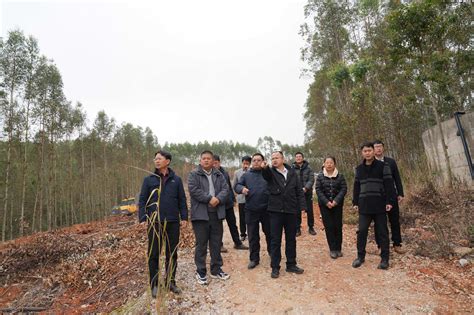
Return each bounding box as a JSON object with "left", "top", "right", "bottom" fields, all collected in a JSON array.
[{"left": 0, "top": 205, "right": 474, "bottom": 314}]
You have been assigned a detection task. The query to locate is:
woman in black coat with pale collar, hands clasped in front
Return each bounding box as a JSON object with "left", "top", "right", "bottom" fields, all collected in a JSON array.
[{"left": 316, "top": 156, "right": 347, "bottom": 259}]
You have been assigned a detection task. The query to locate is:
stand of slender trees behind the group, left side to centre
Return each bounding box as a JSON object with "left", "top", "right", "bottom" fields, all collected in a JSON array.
[{"left": 0, "top": 30, "right": 301, "bottom": 241}]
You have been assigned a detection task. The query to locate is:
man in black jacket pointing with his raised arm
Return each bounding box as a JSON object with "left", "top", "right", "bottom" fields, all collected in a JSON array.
[{"left": 262, "top": 151, "right": 305, "bottom": 278}]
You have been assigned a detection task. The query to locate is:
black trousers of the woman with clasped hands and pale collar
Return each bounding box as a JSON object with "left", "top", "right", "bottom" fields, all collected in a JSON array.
[{"left": 319, "top": 205, "right": 343, "bottom": 251}]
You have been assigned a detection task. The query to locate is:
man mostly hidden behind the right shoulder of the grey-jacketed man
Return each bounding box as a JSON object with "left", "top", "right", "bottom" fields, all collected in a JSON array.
[{"left": 214, "top": 154, "right": 249, "bottom": 253}]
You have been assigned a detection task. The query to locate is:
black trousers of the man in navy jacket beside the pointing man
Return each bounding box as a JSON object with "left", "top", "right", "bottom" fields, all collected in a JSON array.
[{"left": 245, "top": 209, "right": 271, "bottom": 262}]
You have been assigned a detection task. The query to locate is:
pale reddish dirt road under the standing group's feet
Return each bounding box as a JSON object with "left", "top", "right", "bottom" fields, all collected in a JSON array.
[{"left": 129, "top": 210, "right": 474, "bottom": 314}]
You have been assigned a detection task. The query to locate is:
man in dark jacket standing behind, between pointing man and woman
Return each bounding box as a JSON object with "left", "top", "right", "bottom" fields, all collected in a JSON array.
[{"left": 293, "top": 152, "right": 316, "bottom": 236}]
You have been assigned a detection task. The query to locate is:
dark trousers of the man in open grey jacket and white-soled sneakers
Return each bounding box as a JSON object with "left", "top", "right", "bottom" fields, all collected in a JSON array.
[{"left": 193, "top": 212, "right": 224, "bottom": 275}]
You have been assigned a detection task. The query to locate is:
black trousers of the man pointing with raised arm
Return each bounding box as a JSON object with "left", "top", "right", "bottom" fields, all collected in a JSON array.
[{"left": 269, "top": 212, "right": 296, "bottom": 269}]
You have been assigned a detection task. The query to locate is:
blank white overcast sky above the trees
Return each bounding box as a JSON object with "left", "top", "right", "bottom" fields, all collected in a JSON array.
[{"left": 0, "top": 0, "right": 309, "bottom": 145}]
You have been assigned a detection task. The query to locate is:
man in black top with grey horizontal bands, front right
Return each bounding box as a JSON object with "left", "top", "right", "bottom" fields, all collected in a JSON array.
[{"left": 352, "top": 142, "right": 395, "bottom": 269}]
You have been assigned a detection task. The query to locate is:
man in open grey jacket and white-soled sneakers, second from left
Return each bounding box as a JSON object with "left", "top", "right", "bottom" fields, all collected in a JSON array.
[{"left": 188, "top": 151, "right": 230, "bottom": 285}]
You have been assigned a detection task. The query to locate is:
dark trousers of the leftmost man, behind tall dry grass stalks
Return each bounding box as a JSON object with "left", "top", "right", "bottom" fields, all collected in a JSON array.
[{"left": 148, "top": 222, "right": 179, "bottom": 287}]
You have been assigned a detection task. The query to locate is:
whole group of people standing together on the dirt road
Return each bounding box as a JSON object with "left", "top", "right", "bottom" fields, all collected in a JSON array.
[{"left": 139, "top": 141, "right": 403, "bottom": 297}]
